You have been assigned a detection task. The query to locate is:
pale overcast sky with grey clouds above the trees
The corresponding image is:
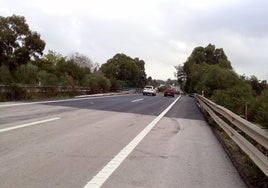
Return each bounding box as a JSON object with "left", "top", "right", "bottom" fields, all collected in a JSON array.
[{"left": 0, "top": 0, "right": 268, "bottom": 80}]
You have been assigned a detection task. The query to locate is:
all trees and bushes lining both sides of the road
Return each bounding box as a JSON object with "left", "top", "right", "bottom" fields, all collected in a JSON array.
[{"left": 0, "top": 15, "right": 268, "bottom": 131}]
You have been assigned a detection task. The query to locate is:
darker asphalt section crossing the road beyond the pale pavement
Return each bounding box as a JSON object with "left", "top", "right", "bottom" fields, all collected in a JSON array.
[{"left": 41, "top": 95, "right": 205, "bottom": 120}]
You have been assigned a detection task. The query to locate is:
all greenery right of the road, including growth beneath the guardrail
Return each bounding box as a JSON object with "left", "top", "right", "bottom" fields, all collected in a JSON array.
[{"left": 176, "top": 44, "right": 268, "bottom": 188}]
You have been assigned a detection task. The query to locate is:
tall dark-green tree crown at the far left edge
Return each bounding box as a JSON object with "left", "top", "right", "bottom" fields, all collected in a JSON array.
[{"left": 0, "top": 15, "right": 45, "bottom": 72}]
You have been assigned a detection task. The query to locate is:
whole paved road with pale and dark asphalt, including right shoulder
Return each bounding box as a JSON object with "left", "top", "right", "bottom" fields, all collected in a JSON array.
[{"left": 0, "top": 94, "right": 245, "bottom": 188}]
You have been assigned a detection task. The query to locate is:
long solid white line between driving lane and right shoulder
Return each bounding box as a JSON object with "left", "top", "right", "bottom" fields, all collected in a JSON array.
[{"left": 84, "top": 96, "right": 181, "bottom": 188}]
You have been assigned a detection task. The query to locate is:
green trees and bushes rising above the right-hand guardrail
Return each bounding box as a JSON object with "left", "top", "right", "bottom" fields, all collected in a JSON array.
[{"left": 176, "top": 44, "right": 268, "bottom": 127}]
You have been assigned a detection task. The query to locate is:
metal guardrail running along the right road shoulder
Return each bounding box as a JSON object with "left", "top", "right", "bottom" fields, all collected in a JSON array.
[{"left": 195, "top": 95, "right": 268, "bottom": 176}]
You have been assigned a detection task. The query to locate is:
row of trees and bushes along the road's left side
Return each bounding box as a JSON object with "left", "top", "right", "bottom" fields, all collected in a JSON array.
[{"left": 0, "top": 15, "right": 147, "bottom": 100}]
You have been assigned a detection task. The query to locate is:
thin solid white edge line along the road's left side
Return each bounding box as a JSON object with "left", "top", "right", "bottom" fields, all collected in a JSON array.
[{"left": 0, "top": 95, "right": 130, "bottom": 108}]
